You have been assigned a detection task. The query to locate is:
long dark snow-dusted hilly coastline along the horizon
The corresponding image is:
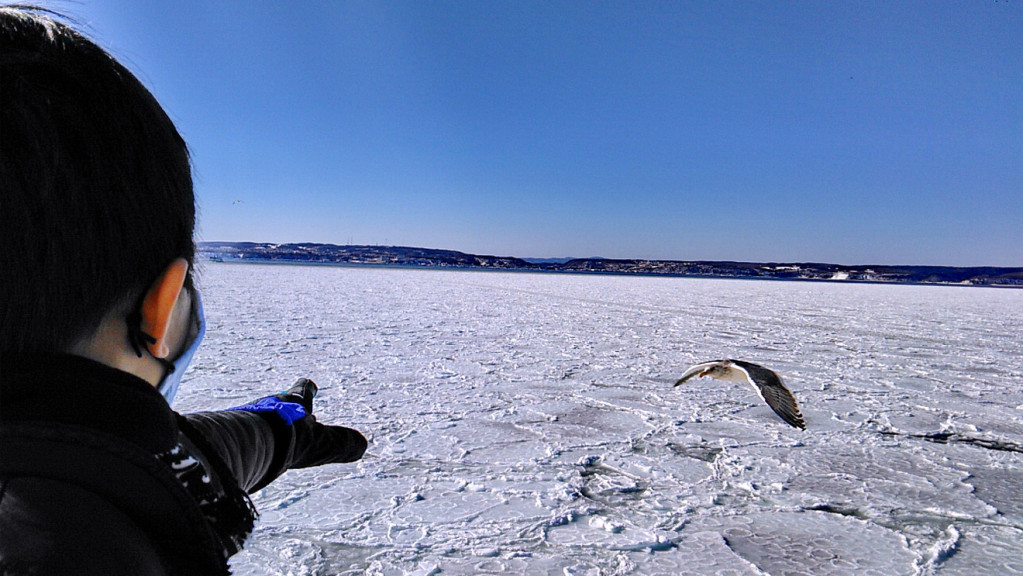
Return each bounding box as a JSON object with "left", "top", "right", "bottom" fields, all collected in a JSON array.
[{"left": 198, "top": 242, "right": 1023, "bottom": 286}]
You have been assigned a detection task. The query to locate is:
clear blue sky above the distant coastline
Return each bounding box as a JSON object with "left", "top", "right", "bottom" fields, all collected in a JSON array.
[{"left": 68, "top": 0, "right": 1023, "bottom": 266}]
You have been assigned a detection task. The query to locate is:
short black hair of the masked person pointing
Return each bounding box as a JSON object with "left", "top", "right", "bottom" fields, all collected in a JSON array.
[{"left": 0, "top": 6, "right": 195, "bottom": 357}]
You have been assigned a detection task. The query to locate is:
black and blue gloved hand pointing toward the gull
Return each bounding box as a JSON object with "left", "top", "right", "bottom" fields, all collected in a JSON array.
[{"left": 229, "top": 378, "right": 367, "bottom": 470}]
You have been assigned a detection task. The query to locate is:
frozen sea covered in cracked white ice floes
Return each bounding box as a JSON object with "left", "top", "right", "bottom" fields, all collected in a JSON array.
[{"left": 175, "top": 263, "right": 1023, "bottom": 576}]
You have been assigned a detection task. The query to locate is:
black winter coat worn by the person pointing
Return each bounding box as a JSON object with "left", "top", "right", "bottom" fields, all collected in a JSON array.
[{"left": 0, "top": 356, "right": 366, "bottom": 576}]
